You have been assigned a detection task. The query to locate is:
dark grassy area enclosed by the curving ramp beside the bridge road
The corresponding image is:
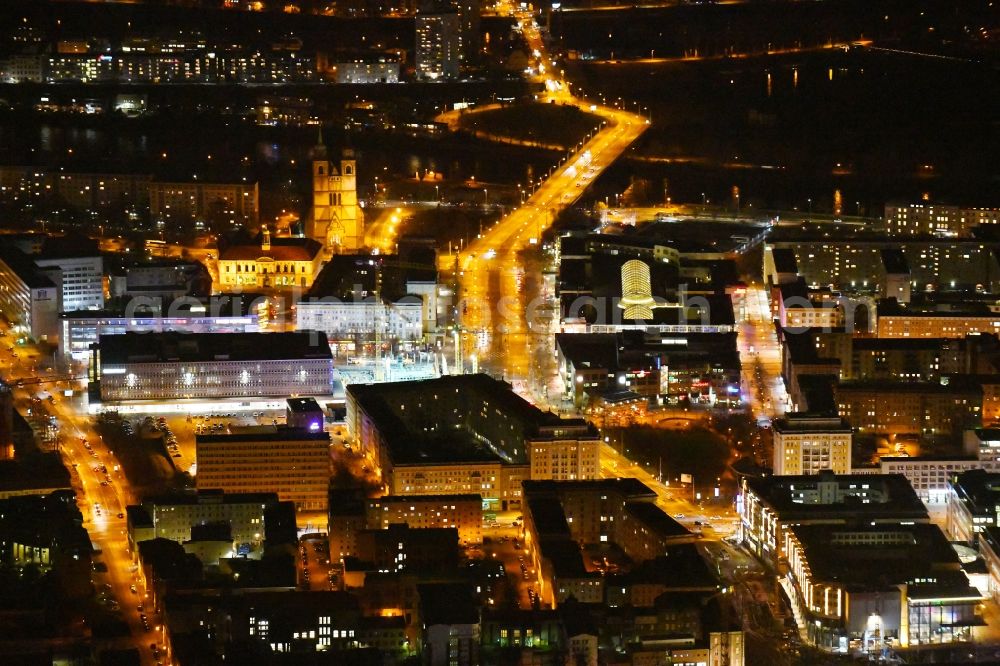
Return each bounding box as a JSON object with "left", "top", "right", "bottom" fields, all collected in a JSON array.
[{"left": 461, "top": 102, "right": 601, "bottom": 148}]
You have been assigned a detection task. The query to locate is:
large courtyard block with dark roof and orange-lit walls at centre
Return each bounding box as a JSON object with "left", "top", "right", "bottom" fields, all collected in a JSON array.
[{"left": 347, "top": 375, "right": 600, "bottom": 509}]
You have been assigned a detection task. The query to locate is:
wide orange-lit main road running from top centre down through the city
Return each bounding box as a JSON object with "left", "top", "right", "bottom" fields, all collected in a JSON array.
[{"left": 448, "top": 6, "right": 752, "bottom": 538}]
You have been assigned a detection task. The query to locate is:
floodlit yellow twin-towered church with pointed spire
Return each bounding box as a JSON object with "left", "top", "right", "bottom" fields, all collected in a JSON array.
[{"left": 306, "top": 130, "right": 365, "bottom": 254}]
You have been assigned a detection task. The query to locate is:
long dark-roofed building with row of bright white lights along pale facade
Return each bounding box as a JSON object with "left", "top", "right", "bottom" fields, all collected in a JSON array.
[{"left": 90, "top": 332, "right": 333, "bottom": 402}]
